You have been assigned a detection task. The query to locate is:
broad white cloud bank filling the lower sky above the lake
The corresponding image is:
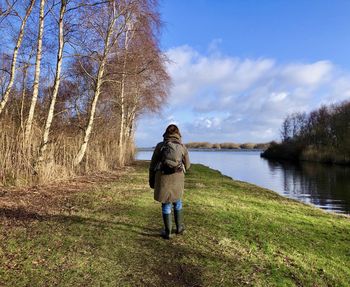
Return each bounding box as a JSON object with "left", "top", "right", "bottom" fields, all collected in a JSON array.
[{"left": 137, "top": 45, "right": 350, "bottom": 146}]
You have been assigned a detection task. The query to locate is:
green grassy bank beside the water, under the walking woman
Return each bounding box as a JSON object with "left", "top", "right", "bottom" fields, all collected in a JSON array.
[{"left": 0, "top": 163, "right": 350, "bottom": 286}]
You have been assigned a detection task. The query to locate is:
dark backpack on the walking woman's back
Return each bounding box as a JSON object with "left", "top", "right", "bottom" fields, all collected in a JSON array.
[{"left": 160, "top": 141, "right": 183, "bottom": 174}]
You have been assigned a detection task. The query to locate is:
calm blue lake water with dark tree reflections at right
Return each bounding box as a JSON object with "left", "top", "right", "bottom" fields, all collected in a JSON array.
[{"left": 136, "top": 150, "right": 350, "bottom": 214}]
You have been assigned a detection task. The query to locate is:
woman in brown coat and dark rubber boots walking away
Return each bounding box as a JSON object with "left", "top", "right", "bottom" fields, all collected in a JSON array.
[{"left": 149, "top": 125, "right": 190, "bottom": 239}]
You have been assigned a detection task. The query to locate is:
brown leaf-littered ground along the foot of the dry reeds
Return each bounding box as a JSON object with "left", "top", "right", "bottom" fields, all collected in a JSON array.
[{"left": 0, "top": 167, "right": 131, "bottom": 226}]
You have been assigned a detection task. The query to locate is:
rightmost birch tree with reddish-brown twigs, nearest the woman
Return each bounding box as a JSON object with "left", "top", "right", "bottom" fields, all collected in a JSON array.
[{"left": 116, "top": 7, "right": 170, "bottom": 165}]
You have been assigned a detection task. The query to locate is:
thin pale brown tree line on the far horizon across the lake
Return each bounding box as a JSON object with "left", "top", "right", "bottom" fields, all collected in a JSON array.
[{"left": 186, "top": 142, "right": 269, "bottom": 150}]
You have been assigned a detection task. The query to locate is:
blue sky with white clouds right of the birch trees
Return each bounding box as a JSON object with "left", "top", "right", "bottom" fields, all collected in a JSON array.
[{"left": 136, "top": 0, "right": 350, "bottom": 146}]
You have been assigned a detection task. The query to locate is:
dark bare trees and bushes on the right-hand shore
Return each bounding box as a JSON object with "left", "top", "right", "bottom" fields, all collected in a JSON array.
[{"left": 263, "top": 101, "right": 350, "bottom": 164}]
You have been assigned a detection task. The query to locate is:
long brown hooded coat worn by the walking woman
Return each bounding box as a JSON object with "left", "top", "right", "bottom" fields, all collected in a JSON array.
[{"left": 149, "top": 134, "right": 190, "bottom": 203}]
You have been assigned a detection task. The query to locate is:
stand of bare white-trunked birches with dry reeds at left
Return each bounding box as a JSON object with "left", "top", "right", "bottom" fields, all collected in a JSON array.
[{"left": 0, "top": 0, "right": 170, "bottom": 185}]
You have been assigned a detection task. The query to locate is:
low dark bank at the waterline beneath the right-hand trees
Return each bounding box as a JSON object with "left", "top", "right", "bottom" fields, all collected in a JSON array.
[{"left": 261, "top": 142, "right": 350, "bottom": 165}]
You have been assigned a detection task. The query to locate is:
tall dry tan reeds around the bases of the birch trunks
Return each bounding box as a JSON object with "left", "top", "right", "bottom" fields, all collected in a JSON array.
[{"left": 0, "top": 122, "right": 133, "bottom": 187}]
